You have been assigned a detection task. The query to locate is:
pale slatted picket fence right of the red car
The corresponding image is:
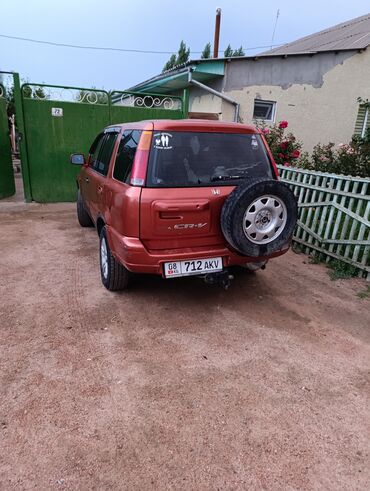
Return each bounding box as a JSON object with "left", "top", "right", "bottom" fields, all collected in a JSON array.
[{"left": 278, "top": 166, "right": 370, "bottom": 278}]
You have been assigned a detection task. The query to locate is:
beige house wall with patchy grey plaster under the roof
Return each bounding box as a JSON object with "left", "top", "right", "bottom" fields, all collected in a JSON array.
[{"left": 191, "top": 50, "right": 370, "bottom": 151}]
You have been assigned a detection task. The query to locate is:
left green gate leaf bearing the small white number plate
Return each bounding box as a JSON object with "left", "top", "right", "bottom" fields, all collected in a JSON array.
[{"left": 22, "top": 84, "right": 110, "bottom": 202}]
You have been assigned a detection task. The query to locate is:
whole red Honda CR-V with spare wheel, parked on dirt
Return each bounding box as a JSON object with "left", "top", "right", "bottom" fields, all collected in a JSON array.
[{"left": 71, "top": 120, "right": 297, "bottom": 290}]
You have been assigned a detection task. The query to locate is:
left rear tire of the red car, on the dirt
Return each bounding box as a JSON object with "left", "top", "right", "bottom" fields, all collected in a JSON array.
[{"left": 99, "top": 227, "right": 130, "bottom": 292}]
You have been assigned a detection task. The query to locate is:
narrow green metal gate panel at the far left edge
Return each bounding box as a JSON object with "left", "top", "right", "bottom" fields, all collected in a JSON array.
[{"left": 0, "top": 85, "right": 15, "bottom": 199}]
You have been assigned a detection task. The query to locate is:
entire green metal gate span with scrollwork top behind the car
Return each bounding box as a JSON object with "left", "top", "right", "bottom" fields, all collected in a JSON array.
[{"left": 21, "top": 84, "right": 184, "bottom": 202}]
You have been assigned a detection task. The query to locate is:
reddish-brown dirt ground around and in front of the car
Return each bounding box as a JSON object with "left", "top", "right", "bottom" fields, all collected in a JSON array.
[{"left": 0, "top": 202, "right": 370, "bottom": 490}]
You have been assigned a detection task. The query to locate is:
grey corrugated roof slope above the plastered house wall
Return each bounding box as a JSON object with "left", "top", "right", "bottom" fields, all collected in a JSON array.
[{"left": 258, "top": 14, "right": 370, "bottom": 56}]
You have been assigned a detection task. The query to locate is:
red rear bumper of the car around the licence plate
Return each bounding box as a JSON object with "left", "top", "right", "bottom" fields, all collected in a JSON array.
[{"left": 107, "top": 227, "right": 290, "bottom": 275}]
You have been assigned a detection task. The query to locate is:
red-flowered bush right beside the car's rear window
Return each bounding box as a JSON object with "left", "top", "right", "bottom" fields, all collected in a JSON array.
[{"left": 257, "top": 121, "right": 302, "bottom": 166}]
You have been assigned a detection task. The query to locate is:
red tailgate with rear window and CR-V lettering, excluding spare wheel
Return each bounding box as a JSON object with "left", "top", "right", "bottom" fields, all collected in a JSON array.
[{"left": 140, "top": 131, "right": 272, "bottom": 250}]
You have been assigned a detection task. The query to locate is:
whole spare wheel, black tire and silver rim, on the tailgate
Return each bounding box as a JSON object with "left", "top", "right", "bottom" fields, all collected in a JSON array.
[{"left": 221, "top": 179, "right": 297, "bottom": 257}]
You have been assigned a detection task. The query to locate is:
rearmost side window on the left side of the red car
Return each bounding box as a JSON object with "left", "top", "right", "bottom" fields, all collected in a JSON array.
[{"left": 113, "top": 130, "right": 141, "bottom": 182}]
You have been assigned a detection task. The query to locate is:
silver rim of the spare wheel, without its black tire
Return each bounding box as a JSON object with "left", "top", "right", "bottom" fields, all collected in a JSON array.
[{"left": 243, "top": 195, "right": 287, "bottom": 244}]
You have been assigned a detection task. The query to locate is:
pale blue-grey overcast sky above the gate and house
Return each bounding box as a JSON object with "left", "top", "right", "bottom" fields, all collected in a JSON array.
[{"left": 0, "top": 0, "right": 370, "bottom": 90}]
